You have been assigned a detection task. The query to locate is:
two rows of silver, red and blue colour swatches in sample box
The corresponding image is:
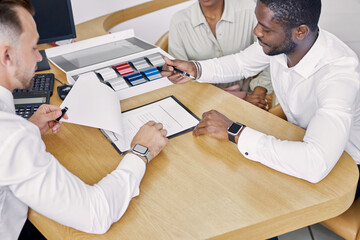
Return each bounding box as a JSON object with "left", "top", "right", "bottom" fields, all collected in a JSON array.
[{"left": 75, "top": 53, "right": 165, "bottom": 91}]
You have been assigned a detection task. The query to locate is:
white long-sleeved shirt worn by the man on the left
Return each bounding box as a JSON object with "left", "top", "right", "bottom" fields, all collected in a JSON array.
[{"left": 0, "top": 86, "right": 145, "bottom": 240}]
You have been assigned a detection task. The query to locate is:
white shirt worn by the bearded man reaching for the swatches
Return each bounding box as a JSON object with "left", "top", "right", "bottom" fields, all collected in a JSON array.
[{"left": 199, "top": 30, "right": 360, "bottom": 182}]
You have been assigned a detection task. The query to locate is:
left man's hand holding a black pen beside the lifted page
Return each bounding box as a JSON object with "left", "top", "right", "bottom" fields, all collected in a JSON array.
[{"left": 29, "top": 104, "right": 68, "bottom": 134}]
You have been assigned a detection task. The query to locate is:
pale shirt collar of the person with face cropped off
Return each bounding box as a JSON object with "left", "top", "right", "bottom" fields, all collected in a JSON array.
[{"left": 191, "top": 0, "right": 235, "bottom": 27}]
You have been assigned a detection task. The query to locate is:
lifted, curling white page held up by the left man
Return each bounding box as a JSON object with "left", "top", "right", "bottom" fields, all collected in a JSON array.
[{"left": 60, "top": 72, "right": 122, "bottom": 134}]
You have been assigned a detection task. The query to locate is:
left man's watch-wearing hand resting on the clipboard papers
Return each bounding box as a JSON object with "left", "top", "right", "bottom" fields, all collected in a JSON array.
[{"left": 131, "top": 121, "right": 168, "bottom": 163}]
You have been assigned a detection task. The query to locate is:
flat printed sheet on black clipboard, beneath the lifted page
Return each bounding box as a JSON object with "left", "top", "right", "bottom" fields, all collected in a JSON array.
[{"left": 103, "top": 96, "right": 199, "bottom": 153}]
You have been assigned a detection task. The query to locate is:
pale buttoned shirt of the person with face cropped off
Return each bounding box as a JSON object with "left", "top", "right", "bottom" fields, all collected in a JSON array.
[{"left": 169, "top": 0, "right": 273, "bottom": 93}]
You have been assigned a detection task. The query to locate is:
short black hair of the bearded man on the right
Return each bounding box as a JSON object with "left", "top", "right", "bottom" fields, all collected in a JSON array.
[{"left": 259, "top": 0, "right": 321, "bottom": 31}]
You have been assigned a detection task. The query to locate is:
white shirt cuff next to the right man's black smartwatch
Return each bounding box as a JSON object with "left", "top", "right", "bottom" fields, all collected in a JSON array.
[{"left": 237, "top": 127, "right": 264, "bottom": 161}]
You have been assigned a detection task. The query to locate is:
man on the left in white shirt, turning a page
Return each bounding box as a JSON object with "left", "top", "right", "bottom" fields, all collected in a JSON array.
[{"left": 0, "top": 0, "right": 168, "bottom": 240}]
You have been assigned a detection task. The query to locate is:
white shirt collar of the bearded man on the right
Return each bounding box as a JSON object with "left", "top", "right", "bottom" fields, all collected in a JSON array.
[{"left": 275, "top": 29, "right": 326, "bottom": 78}]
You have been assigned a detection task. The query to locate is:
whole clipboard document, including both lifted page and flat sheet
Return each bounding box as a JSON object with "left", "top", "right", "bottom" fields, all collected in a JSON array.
[{"left": 60, "top": 72, "right": 199, "bottom": 153}]
